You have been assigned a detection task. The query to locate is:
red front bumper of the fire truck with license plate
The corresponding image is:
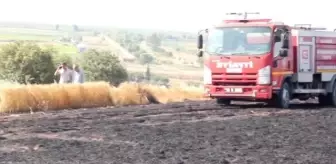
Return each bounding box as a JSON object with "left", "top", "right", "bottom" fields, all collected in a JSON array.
[{"left": 204, "top": 85, "right": 272, "bottom": 100}]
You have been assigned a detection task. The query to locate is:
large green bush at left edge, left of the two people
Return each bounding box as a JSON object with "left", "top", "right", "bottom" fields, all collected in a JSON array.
[{"left": 0, "top": 42, "right": 55, "bottom": 84}]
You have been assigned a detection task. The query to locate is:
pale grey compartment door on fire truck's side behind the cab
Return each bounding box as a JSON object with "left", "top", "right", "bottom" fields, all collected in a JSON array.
[{"left": 298, "top": 45, "right": 314, "bottom": 72}]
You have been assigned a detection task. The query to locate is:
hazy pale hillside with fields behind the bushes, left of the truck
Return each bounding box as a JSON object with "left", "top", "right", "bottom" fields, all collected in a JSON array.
[{"left": 0, "top": 23, "right": 202, "bottom": 84}]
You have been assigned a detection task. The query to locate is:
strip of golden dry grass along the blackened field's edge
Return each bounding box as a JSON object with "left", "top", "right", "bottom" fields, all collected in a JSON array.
[{"left": 0, "top": 82, "right": 203, "bottom": 112}]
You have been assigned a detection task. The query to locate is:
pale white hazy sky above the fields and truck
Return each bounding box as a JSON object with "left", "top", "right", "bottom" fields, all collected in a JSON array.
[{"left": 0, "top": 0, "right": 336, "bottom": 31}]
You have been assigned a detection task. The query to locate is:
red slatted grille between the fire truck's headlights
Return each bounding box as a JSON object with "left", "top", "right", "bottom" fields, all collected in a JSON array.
[{"left": 212, "top": 73, "right": 257, "bottom": 86}]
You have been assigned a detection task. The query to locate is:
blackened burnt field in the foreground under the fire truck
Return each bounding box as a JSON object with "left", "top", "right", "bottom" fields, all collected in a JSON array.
[{"left": 0, "top": 101, "right": 336, "bottom": 164}]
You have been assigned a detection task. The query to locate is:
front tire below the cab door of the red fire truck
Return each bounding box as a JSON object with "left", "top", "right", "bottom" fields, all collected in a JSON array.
[{"left": 276, "top": 82, "right": 291, "bottom": 109}]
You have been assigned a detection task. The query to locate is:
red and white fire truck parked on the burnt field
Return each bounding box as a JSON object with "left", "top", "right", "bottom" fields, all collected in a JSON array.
[{"left": 197, "top": 13, "right": 336, "bottom": 108}]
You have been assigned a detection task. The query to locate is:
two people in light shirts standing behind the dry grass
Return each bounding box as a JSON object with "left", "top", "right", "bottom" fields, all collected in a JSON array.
[{"left": 54, "top": 63, "right": 84, "bottom": 84}]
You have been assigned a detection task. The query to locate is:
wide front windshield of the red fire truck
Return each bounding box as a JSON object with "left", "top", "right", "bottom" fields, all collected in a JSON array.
[{"left": 206, "top": 27, "right": 272, "bottom": 55}]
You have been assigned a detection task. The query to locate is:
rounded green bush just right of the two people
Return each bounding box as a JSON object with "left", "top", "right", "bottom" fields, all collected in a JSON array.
[{"left": 79, "top": 49, "right": 128, "bottom": 85}]
